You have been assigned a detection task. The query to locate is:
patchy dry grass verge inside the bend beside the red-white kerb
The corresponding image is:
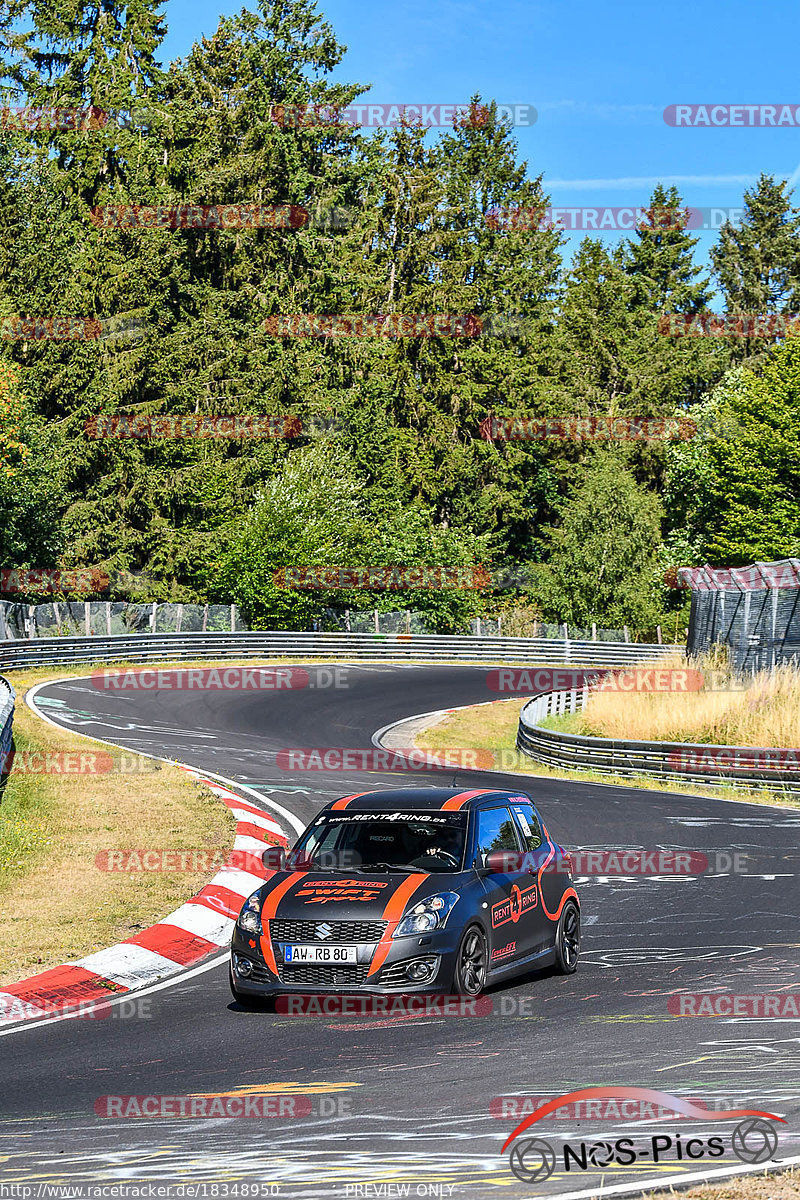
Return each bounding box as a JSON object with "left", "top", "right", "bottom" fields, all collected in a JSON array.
[{"left": 0, "top": 667, "right": 235, "bottom": 985}]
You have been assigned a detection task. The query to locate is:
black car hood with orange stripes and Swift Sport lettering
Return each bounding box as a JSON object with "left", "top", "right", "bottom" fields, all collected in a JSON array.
[{"left": 260, "top": 871, "right": 455, "bottom": 920}]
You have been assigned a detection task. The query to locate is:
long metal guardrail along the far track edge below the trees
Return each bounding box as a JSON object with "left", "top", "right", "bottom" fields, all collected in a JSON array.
[{"left": 0, "top": 631, "right": 685, "bottom": 670}]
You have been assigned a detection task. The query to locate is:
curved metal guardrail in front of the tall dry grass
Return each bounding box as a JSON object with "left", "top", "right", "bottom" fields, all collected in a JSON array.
[{"left": 517, "top": 688, "right": 800, "bottom": 793}]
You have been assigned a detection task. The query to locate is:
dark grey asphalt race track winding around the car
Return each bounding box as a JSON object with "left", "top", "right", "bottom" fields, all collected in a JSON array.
[{"left": 0, "top": 665, "right": 800, "bottom": 1200}]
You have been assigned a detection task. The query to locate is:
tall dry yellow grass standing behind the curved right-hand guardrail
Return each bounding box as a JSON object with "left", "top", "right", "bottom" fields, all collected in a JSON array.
[{"left": 581, "top": 660, "right": 800, "bottom": 749}]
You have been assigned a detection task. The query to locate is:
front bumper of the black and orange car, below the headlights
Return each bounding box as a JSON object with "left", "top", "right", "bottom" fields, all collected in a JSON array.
[{"left": 230, "top": 925, "right": 461, "bottom": 996}]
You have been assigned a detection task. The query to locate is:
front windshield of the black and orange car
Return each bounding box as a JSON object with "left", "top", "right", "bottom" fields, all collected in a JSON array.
[{"left": 288, "top": 811, "right": 467, "bottom": 874}]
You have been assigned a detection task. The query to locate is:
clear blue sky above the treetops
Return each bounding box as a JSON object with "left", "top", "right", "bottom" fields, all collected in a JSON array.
[{"left": 163, "top": 0, "right": 800, "bottom": 273}]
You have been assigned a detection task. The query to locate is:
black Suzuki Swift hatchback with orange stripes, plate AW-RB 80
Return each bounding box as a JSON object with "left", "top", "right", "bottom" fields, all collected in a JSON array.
[{"left": 230, "top": 787, "right": 581, "bottom": 1004}]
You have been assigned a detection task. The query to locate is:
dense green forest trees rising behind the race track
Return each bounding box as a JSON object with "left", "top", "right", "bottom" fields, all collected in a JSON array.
[{"left": 0, "top": 0, "right": 800, "bottom": 630}]
